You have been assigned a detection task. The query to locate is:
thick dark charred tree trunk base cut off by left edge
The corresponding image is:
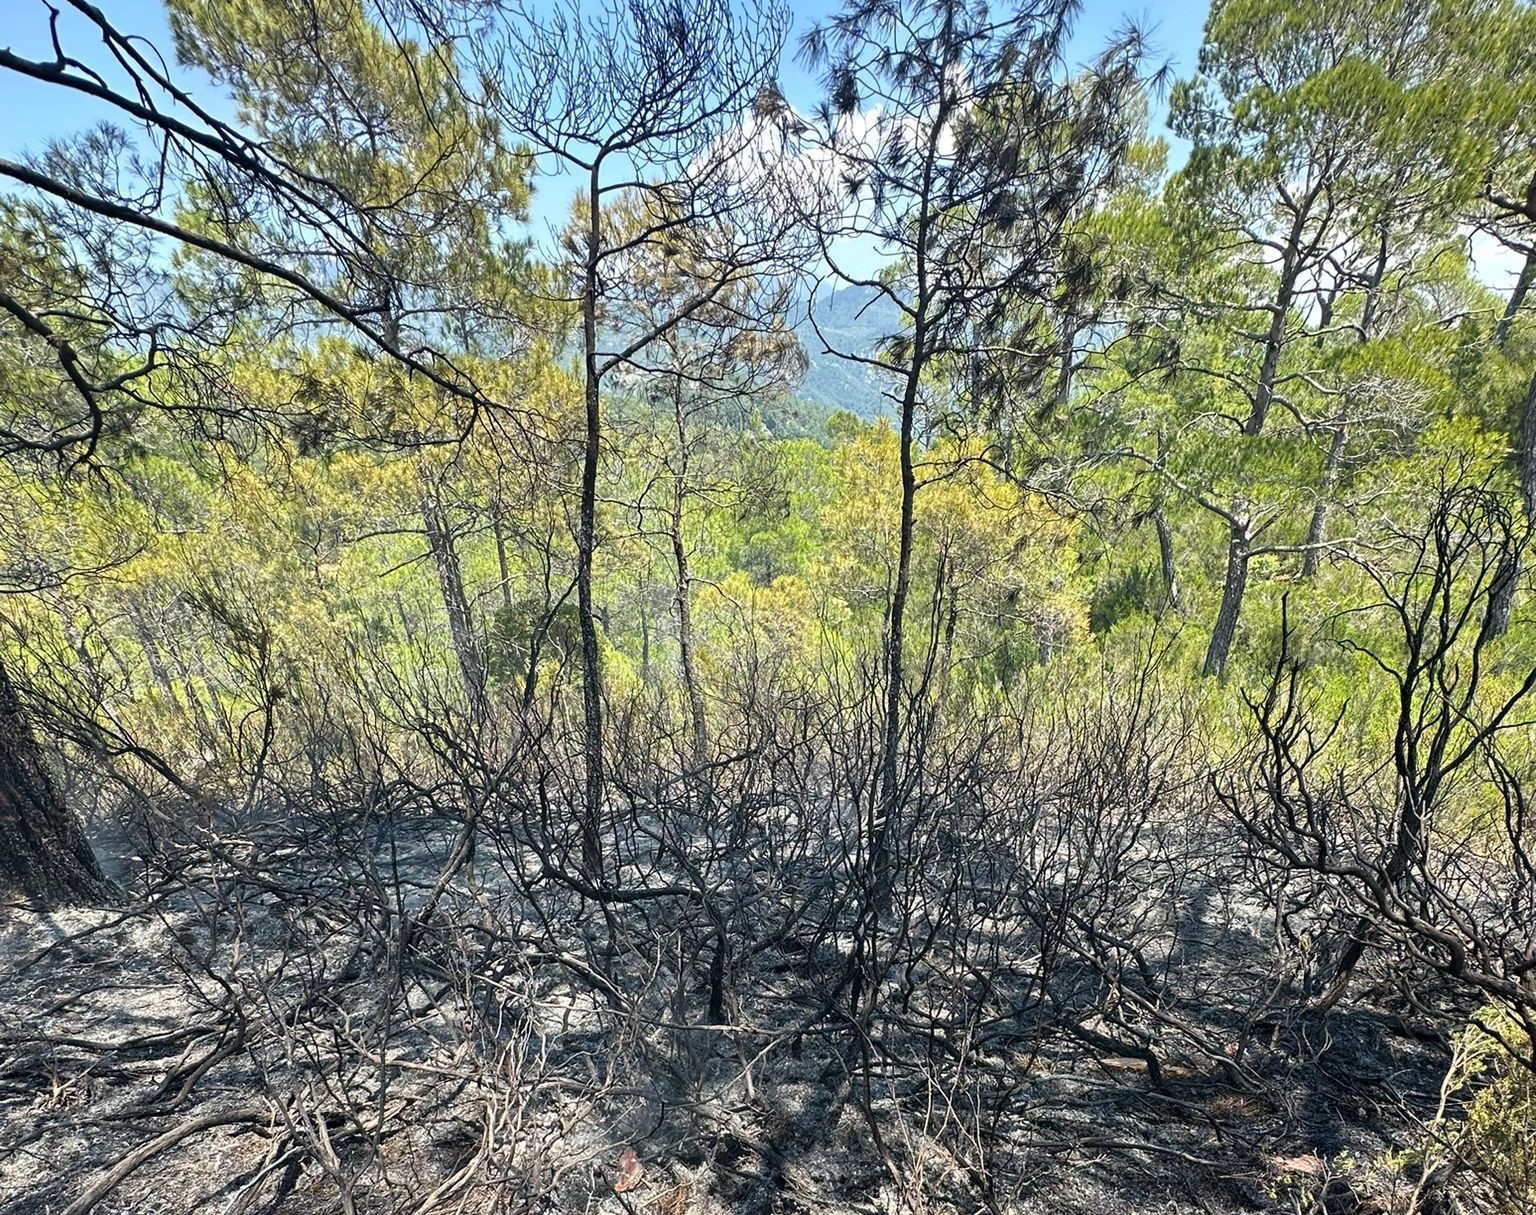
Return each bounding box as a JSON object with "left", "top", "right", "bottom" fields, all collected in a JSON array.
[{"left": 0, "top": 667, "right": 117, "bottom": 908}]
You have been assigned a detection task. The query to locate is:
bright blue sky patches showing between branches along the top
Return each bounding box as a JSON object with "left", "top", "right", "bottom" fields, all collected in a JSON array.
[{"left": 0, "top": 0, "right": 1207, "bottom": 217}]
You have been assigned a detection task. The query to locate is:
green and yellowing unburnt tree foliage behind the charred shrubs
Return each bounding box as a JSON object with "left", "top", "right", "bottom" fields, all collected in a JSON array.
[{"left": 0, "top": 0, "right": 1536, "bottom": 872}]
